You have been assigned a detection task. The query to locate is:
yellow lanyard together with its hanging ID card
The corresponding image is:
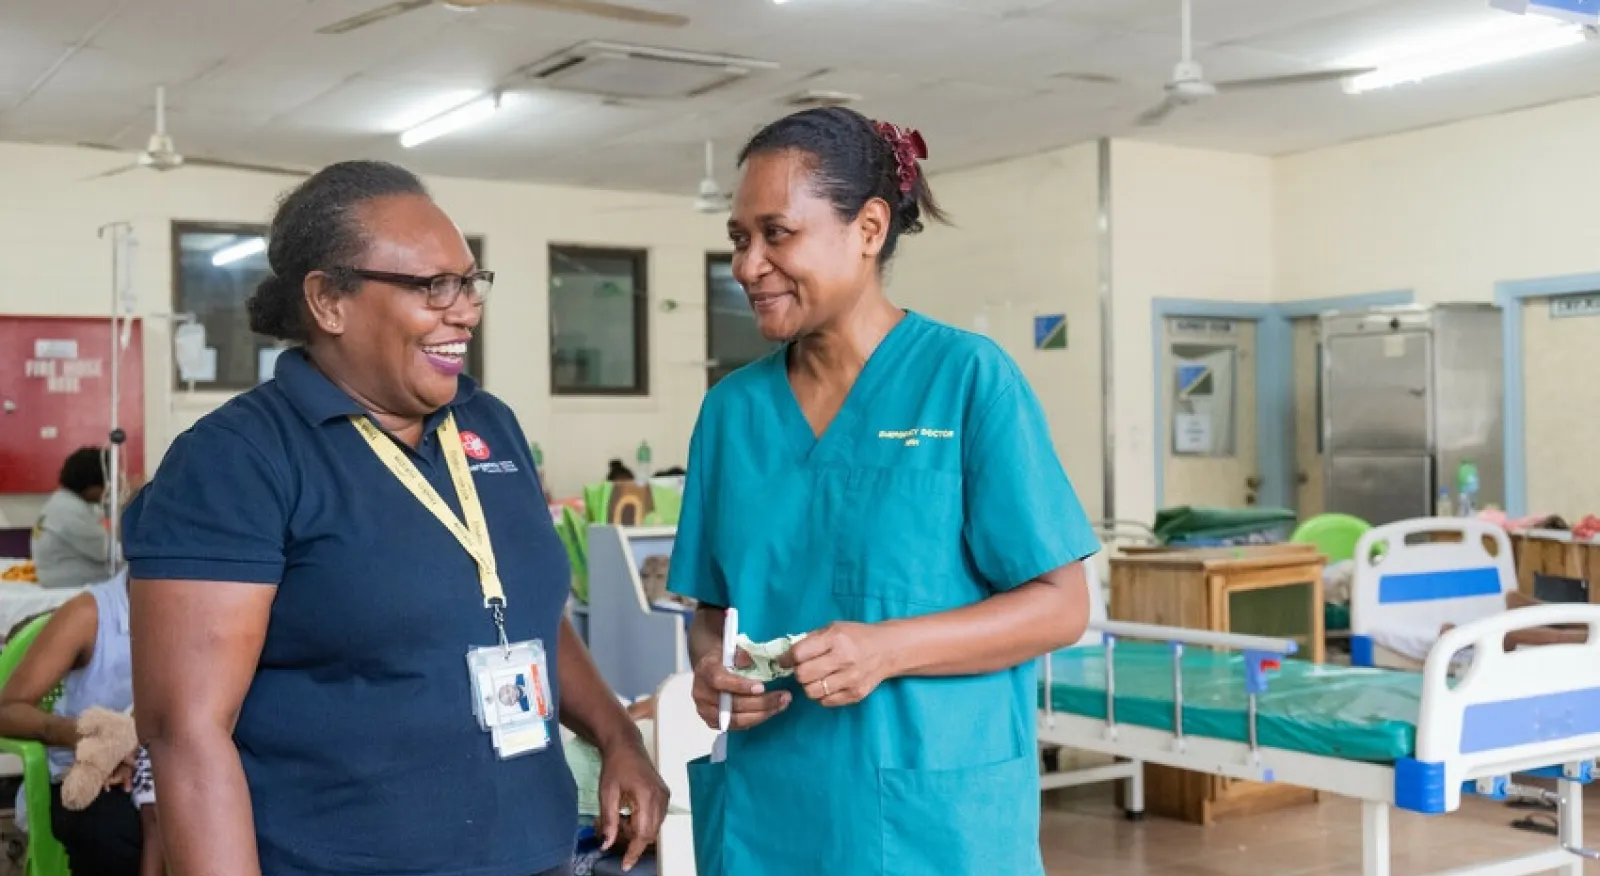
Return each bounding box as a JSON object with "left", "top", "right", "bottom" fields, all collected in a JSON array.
[{"left": 350, "top": 414, "right": 555, "bottom": 758}]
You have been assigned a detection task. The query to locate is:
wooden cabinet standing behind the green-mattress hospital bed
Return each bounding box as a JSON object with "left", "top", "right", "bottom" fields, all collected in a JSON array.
[{"left": 1110, "top": 545, "right": 1326, "bottom": 825}]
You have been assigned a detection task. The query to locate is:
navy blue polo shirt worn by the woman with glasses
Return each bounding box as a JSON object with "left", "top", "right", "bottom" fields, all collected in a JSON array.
[{"left": 125, "top": 350, "right": 578, "bottom": 876}]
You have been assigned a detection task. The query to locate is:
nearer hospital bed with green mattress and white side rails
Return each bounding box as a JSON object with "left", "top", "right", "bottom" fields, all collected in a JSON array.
[{"left": 1038, "top": 604, "right": 1600, "bottom": 876}]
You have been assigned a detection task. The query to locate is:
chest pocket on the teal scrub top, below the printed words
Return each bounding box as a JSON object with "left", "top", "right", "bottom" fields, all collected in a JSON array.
[{"left": 834, "top": 467, "right": 981, "bottom": 609}]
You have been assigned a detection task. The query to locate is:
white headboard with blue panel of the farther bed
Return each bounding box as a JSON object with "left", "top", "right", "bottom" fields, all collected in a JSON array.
[{"left": 1350, "top": 518, "right": 1517, "bottom": 670}]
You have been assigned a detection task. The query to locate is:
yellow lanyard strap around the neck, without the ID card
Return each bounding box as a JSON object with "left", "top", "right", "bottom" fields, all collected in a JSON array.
[{"left": 350, "top": 414, "right": 506, "bottom": 644}]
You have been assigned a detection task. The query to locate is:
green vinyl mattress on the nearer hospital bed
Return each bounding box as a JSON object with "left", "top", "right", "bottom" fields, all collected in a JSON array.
[{"left": 1038, "top": 641, "right": 1422, "bottom": 764}]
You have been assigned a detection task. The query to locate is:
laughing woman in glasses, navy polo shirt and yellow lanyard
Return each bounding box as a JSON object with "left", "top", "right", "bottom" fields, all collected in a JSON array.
[{"left": 125, "top": 161, "right": 667, "bottom": 876}]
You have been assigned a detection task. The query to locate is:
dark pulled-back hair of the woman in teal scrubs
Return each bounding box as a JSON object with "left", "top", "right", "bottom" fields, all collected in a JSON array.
[{"left": 739, "top": 107, "right": 946, "bottom": 265}]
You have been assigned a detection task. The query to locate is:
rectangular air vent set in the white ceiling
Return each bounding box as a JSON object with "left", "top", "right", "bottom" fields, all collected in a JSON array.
[{"left": 518, "top": 40, "right": 778, "bottom": 99}]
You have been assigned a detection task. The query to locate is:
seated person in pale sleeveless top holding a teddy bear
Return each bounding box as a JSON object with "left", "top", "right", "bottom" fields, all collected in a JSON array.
[{"left": 0, "top": 571, "right": 162, "bottom": 876}]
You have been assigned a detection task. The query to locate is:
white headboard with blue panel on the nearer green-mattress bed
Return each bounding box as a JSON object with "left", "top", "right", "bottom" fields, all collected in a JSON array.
[{"left": 1395, "top": 604, "right": 1600, "bottom": 812}]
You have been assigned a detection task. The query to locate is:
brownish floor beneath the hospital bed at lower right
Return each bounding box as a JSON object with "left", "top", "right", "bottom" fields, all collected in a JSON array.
[{"left": 1043, "top": 786, "right": 1600, "bottom": 876}]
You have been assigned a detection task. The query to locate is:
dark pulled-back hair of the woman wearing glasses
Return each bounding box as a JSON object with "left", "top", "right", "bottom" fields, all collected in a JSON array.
[{"left": 246, "top": 161, "right": 427, "bottom": 342}]
